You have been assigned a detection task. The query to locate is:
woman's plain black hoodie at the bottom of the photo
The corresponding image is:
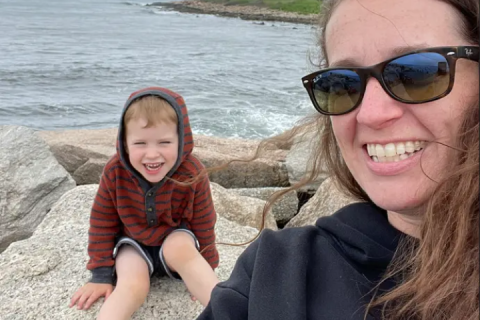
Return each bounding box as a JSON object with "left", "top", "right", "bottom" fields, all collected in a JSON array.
[{"left": 198, "top": 203, "right": 403, "bottom": 320}]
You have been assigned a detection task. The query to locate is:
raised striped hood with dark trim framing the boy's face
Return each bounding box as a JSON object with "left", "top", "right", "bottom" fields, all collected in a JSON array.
[{"left": 117, "top": 87, "right": 194, "bottom": 189}]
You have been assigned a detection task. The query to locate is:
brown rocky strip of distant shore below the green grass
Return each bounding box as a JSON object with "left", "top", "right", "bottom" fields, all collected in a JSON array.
[{"left": 151, "top": 0, "right": 318, "bottom": 25}]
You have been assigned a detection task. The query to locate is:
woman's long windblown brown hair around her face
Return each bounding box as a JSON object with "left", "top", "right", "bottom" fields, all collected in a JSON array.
[{"left": 318, "top": 0, "right": 479, "bottom": 320}]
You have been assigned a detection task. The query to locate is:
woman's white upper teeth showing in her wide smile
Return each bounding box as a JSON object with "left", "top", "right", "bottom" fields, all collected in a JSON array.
[{"left": 367, "top": 141, "right": 425, "bottom": 162}]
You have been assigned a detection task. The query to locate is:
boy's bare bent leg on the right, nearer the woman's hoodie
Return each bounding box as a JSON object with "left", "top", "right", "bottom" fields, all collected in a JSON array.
[{"left": 163, "top": 232, "right": 218, "bottom": 306}]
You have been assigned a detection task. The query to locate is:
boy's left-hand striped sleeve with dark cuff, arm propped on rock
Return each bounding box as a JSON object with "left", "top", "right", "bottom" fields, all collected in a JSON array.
[{"left": 87, "top": 171, "right": 120, "bottom": 283}]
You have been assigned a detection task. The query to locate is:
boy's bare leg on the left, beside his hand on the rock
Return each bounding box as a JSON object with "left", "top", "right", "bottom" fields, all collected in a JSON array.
[{"left": 97, "top": 245, "right": 150, "bottom": 320}]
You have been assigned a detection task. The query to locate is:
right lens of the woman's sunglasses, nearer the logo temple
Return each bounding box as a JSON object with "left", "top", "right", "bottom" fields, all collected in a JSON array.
[{"left": 383, "top": 52, "right": 450, "bottom": 102}]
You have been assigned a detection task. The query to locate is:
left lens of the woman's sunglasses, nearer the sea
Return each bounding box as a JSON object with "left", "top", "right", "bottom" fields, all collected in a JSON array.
[{"left": 313, "top": 69, "right": 361, "bottom": 114}]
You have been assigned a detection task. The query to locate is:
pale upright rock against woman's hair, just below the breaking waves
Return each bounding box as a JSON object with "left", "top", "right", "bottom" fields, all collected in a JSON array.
[{"left": 286, "top": 127, "right": 327, "bottom": 193}]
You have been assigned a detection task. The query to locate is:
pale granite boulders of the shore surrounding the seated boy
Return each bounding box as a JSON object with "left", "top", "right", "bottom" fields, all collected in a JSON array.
[{"left": 0, "top": 126, "right": 353, "bottom": 320}]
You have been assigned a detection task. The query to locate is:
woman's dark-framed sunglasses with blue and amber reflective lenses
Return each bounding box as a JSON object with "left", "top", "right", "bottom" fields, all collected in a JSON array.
[{"left": 302, "top": 46, "right": 479, "bottom": 115}]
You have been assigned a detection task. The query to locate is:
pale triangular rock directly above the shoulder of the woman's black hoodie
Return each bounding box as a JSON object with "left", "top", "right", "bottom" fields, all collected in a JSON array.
[{"left": 285, "top": 178, "right": 356, "bottom": 228}]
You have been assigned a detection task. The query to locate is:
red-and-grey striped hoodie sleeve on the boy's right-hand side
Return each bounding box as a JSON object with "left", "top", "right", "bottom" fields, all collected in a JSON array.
[{"left": 190, "top": 177, "right": 219, "bottom": 269}]
